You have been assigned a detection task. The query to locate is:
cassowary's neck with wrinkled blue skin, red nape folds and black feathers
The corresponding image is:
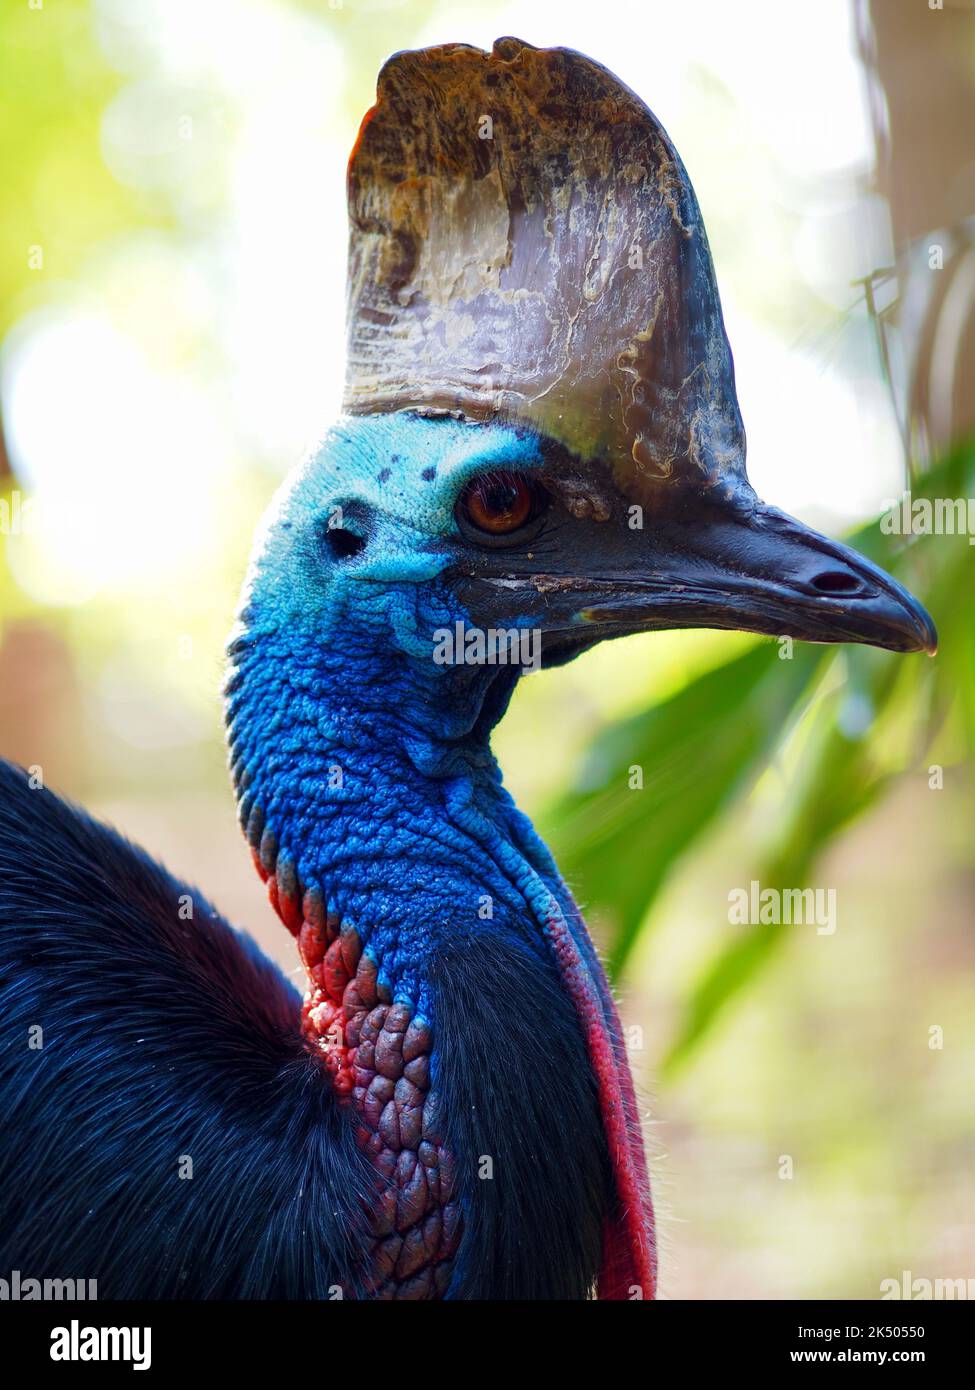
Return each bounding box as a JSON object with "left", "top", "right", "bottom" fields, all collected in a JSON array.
[{"left": 228, "top": 628, "right": 620, "bottom": 1298}]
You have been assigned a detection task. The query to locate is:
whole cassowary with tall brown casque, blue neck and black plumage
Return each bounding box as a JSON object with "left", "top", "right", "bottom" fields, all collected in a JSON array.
[{"left": 0, "top": 39, "right": 935, "bottom": 1300}]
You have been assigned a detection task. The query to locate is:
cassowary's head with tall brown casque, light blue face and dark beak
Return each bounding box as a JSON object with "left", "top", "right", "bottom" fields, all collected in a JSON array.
[{"left": 229, "top": 39, "right": 935, "bottom": 767}]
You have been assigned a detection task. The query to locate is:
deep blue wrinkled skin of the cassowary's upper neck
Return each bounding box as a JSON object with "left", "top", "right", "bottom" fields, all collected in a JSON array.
[{"left": 232, "top": 575, "right": 577, "bottom": 1015}]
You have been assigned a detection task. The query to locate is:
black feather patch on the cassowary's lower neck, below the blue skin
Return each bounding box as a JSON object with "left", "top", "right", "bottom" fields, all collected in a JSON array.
[{"left": 431, "top": 931, "right": 612, "bottom": 1300}]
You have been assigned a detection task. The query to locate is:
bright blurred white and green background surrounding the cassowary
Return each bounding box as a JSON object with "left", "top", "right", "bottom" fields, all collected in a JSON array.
[{"left": 0, "top": 0, "right": 975, "bottom": 1298}]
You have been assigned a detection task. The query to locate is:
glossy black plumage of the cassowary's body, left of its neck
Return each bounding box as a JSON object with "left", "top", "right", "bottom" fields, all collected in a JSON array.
[{"left": 0, "top": 762, "right": 370, "bottom": 1298}]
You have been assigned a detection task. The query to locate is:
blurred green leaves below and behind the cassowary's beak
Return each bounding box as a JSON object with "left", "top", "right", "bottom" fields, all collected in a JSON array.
[{"left": 545, "top": 446, "right": 975, "bottom": 1077}]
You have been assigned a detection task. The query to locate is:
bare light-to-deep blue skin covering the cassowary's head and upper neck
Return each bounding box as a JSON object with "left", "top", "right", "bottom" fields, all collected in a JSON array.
[{"left": 227, "top": 414, "right": 593, "bottom": 1022}]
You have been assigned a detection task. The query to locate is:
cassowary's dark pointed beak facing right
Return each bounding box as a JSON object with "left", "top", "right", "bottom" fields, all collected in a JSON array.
[{"left": 461, "top": 495, "right": 937, "bottom": 655}]
